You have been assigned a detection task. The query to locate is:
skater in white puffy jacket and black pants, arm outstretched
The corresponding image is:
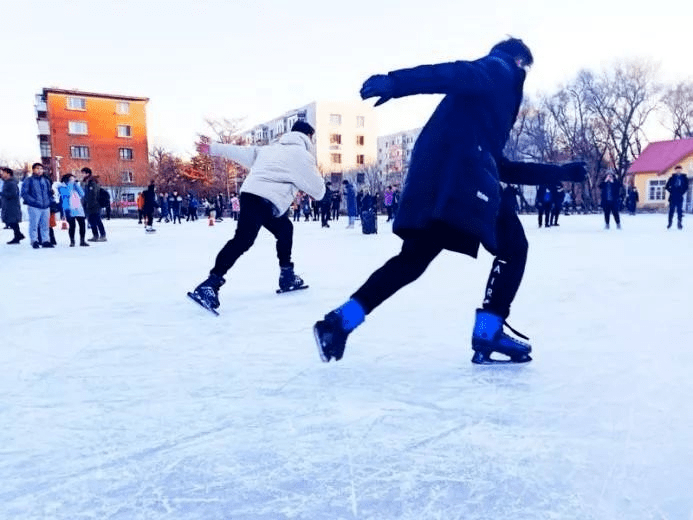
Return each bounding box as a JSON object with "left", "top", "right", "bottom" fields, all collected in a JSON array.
[{"left": 188, "top": 121, "right": 325, "bottom": 311}]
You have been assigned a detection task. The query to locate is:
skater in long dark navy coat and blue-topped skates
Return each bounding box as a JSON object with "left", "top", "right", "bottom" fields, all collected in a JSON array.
[{"left": 313, "top": 38, "right": 586, "bottom": 364}]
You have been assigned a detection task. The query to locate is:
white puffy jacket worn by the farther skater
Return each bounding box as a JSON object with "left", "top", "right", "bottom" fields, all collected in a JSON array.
[{"left": 209, "top": 132, "right": 325, "bottom": 215}]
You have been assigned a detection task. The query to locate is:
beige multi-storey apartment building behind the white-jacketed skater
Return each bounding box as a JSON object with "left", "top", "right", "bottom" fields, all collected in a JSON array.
[{"left": 243, "top": 101, "right": 378, "bottom": 182}]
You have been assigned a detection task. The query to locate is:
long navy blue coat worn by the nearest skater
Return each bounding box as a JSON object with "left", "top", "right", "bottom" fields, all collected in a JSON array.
[{"left": 388, "top": 51, "right": 560, "bottom": 256}]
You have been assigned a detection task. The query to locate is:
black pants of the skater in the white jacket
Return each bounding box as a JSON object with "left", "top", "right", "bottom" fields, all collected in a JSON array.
[{"left": 210, "top": 193, "right": 294, "bottom": 276}]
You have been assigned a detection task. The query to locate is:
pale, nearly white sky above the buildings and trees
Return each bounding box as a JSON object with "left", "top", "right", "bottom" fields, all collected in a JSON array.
[{"left": 0, "top": 0, "right": 693, "bottom": 163}]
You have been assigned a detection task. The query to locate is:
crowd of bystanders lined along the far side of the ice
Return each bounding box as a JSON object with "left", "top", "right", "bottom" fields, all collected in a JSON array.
[{"left": 0, "top": 163, "right": 689, "bottom": 249}]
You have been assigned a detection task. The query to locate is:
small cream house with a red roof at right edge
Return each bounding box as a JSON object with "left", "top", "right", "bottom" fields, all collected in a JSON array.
[{"left": 628, "top": 139, "right": 693, "bottom": 212}]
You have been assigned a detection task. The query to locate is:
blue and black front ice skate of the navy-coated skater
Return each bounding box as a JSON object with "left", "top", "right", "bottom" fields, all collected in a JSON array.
[{"left": 472, "top": 309, "right": 532, "bottom": 365}]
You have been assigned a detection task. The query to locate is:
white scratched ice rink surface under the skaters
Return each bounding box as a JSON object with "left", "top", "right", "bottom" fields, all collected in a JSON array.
[{"left": 0, "top": 215, "right": 693, "bottom": 520}]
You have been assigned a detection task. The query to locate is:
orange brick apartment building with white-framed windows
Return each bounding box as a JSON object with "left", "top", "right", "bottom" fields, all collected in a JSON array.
[{"left": 36, "top": 88, "right": 149, "bottom": 192}]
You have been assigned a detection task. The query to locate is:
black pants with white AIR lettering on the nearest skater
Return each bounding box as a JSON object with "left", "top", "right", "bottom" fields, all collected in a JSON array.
[{"left": 352, "top": 192, "right": 528, "bottom": 319}]
